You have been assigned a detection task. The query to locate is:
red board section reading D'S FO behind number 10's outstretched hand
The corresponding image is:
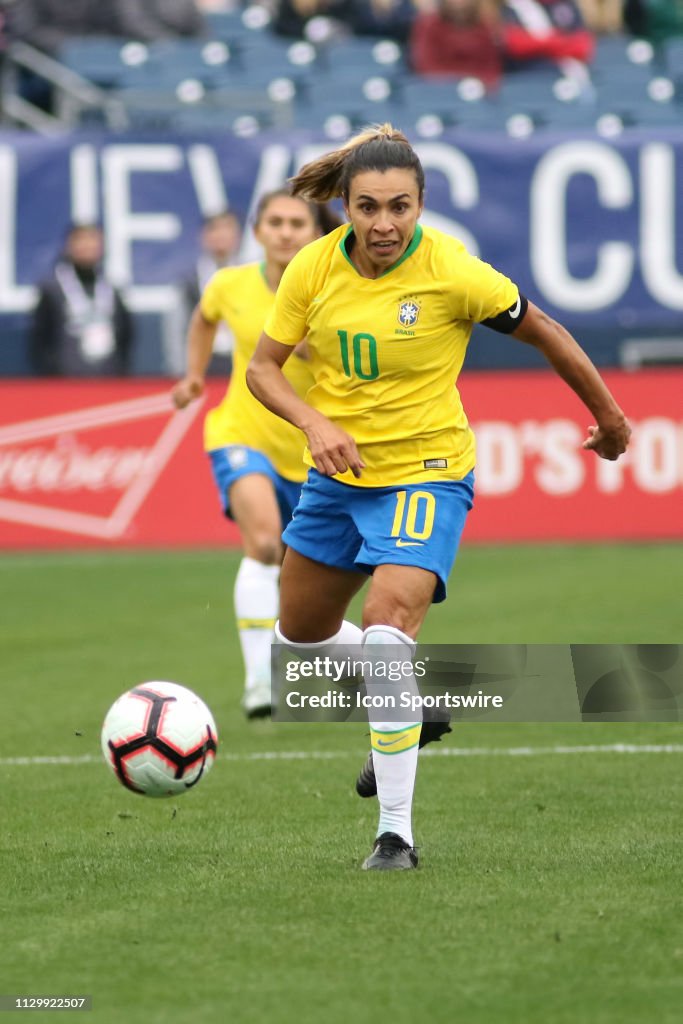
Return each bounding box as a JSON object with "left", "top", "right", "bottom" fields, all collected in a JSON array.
[{"left": 461, "top": 369, "right": 683, "bottom": 541}]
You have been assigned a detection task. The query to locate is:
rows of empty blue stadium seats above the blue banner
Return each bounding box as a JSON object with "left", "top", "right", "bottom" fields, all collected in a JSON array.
[{"left": 53, "top": 25, "right": 683, "bottom": 137}]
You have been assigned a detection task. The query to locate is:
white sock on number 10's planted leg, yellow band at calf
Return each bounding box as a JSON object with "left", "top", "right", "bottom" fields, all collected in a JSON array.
[{"left": 362, "top": 626, "right": 422, "bottom": 846}]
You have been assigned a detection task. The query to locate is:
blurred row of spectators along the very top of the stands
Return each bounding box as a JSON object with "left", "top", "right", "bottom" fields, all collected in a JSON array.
[{"left": 0, "top": 0, "right": 683, "bottom": 70}]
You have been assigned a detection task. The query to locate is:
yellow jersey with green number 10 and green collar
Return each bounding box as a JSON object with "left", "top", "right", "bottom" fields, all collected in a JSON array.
[{"left": 264, "top": 225, "right": 519, "bottom": 486}]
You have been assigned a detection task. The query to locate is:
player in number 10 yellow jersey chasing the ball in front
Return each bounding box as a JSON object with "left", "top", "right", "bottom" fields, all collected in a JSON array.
[{"left": 247, "top": 125, "right": 631, "bottom": 870}]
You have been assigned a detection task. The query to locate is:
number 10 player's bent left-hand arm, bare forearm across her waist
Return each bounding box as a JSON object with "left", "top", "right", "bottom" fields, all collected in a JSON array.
[{"left": 247, "top": 333, "right": 365, "bottom": 477}]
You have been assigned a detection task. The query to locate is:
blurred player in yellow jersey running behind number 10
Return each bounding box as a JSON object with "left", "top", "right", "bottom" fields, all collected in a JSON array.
[{"left": 173, "top": 188, "right": 339, "bottom": 718}]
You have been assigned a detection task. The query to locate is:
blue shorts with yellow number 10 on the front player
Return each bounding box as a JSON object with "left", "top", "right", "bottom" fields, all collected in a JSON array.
[{"left": 283, "top": 469, "right": 474, "bottom": 602}]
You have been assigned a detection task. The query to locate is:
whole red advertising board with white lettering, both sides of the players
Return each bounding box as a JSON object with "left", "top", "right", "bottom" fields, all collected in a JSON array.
[{"left": 0, "top": 370, "right": 683, "bottom": 549}]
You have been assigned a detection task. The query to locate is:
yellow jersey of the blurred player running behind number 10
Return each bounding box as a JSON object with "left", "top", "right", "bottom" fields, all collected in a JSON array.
[{"left": 200, "top": 263, "right": 313, "bottom": 480}]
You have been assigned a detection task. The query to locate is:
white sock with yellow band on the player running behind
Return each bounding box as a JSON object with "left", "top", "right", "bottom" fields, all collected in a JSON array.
[{"left": 234, "top": 556, "right": 280, "bottom": 689}]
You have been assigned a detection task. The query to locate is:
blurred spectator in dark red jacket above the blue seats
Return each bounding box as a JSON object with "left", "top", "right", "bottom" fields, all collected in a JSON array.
[{"left": 411, "top": 0, "right": 503, "bottom": 86}]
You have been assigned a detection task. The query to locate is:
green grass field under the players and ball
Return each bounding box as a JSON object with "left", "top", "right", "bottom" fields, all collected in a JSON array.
[{"left": 0, "top": 545, "right": 683, "bottom": 1024}]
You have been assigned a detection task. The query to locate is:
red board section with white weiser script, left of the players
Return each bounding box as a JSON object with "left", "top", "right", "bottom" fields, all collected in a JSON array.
[{"left": 0, "top": 381, "right": 237, "bottom": 548}]
